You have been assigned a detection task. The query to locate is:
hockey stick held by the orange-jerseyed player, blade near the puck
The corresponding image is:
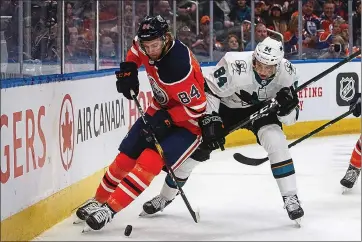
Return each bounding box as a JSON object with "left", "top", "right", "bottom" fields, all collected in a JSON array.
[{"left": 131, "top": 90, "right": 200, "bottom": 223}]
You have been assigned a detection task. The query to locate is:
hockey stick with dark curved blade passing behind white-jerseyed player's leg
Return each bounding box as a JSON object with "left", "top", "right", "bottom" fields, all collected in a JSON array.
[{"left": 234, "top": 105, "right": 356, "bottom": 166}]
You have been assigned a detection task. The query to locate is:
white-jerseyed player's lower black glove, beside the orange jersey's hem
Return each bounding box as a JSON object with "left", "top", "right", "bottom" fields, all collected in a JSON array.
[{"left": 199, "top": 112, "right": 225, "bottom": 150}]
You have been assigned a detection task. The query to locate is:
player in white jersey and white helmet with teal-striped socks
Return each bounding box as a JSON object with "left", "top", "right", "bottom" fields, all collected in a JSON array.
[{"left": 140, "top": 37, "right": 304, "bottom": 223}]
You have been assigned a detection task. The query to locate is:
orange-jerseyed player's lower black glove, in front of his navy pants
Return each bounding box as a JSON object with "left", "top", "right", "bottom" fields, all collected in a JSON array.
[{"left": 141, "top": 109, "right": 173, "bottom": 143}]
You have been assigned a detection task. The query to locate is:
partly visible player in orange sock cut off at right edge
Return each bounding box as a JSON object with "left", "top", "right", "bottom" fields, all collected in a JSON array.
[{"left": 341, "top": 93, "right": 362, "bottom": 190}]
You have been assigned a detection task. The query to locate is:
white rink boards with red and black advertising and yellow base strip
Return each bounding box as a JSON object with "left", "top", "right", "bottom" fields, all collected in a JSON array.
[{"left": 0, "top": 62, "right": 361, "bottom": 240}]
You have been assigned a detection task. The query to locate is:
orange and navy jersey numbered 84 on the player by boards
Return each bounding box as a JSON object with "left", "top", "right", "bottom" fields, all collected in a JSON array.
[{"left": 126, "top": 37, "right": 206, "bottom": 135}]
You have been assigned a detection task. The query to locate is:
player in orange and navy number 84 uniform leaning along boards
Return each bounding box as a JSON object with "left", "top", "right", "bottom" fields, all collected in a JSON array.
[{"left": 72, "top": 15, "right": 225, "bottom": 230}]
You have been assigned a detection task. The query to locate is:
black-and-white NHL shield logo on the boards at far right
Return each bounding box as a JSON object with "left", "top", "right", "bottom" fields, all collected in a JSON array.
[{"left": 336, "top": 72, "right": 359, "bottom": 106}]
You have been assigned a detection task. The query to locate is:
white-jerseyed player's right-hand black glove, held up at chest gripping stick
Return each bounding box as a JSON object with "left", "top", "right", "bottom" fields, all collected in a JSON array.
[{"left": 275, "top": 87, "right": 299, "bottom": 116}]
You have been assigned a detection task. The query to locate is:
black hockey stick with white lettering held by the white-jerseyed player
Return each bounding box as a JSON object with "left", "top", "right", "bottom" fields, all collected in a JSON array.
[{"left": 227, "top": 50, "right": 361, "bottom": 133}]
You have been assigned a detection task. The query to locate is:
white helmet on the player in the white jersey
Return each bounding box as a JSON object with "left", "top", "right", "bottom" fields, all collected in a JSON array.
[{"left": 253, "top": 37, "right": 284, "bottom": 65}]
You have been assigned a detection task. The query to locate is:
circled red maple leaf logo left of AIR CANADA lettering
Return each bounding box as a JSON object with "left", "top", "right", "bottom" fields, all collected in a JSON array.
[{"left": 59, "top": 94, "right": 75, "bottom": 171}]
